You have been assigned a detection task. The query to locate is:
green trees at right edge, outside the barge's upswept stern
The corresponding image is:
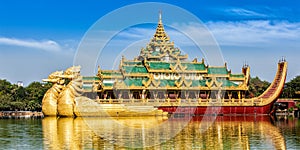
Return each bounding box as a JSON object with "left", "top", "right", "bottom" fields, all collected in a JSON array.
[{"left": 281, "top": 76, "right": 300, "bottom": 98}]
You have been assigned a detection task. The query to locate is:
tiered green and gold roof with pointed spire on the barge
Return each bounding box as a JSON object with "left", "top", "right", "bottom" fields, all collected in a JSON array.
[{"left": 95, "top": 12, "right": 247, "bottom": 90}]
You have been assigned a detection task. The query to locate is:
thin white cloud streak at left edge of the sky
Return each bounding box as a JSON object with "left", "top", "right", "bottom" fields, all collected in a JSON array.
[{"left": 0, "top": 37, "right": 62, "bottom": 51}]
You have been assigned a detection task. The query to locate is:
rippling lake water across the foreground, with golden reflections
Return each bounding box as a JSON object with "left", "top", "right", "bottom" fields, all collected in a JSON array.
[{"left": 0, "top": 116, "right": 300, "bottom": 150}]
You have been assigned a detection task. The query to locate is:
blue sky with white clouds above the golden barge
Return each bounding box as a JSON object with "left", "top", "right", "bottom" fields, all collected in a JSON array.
[{"left": 0, "top": 0, "right": 300, "bottom": 85}]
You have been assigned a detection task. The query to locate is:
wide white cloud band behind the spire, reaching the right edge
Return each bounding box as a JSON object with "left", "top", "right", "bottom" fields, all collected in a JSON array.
[{"left": 84, "top": 20, "right": 300, "bottom": 50}]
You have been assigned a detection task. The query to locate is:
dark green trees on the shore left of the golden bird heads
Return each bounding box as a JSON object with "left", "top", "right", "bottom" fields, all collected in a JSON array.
[{"left": 0, "top": 80, "right": 52, "bottom": 111}]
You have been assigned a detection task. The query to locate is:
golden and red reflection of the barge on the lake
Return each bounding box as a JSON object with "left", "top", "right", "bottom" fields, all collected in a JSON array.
[{"left": 42, "top": 116, "right": 286, "bottom": 149}]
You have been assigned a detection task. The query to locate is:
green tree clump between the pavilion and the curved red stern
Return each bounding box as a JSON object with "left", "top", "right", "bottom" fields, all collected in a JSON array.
[{"left": 249, "top": 77, "right": 270, "bottom": 97}]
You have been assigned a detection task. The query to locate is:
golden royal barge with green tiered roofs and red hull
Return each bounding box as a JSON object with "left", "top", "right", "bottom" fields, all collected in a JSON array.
[{"left": 43, "top": 13, "right": 287, "bottom": 116}]
